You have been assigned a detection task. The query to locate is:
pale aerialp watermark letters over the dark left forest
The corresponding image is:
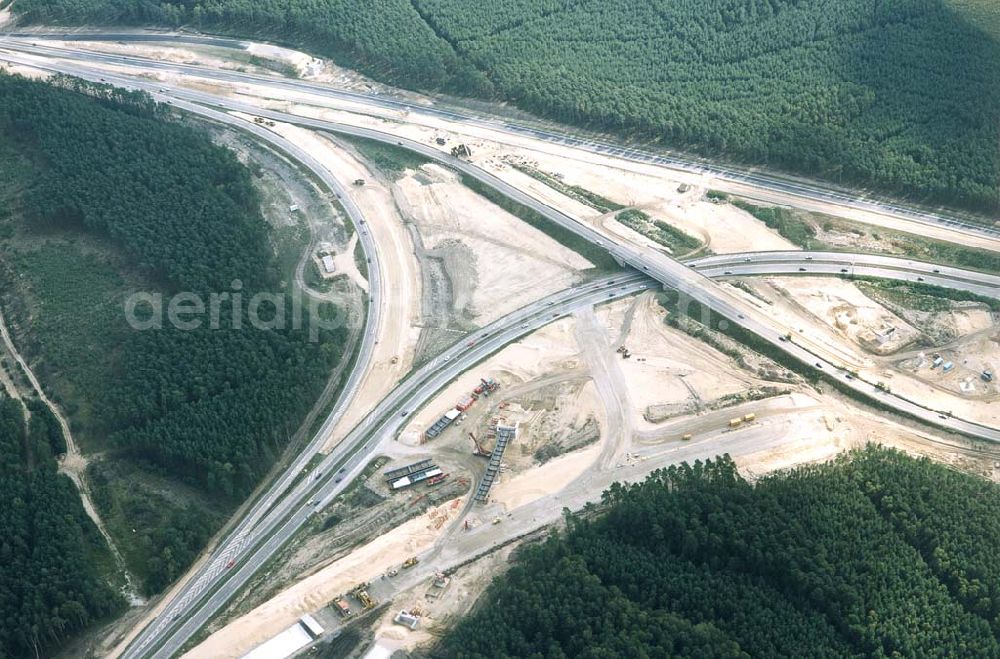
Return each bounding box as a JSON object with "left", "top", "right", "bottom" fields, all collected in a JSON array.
[{"left": 124, "top": 279, "right": 351, "bottom": 342}]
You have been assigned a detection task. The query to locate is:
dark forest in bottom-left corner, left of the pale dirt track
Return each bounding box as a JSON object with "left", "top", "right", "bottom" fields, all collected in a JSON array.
[{"left": 0, "top": 389, "right": 125, "bottom": 657}]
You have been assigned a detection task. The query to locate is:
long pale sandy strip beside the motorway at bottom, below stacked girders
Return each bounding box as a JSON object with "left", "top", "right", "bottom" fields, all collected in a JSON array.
[{"left": 184, "top": 503, "right": 462, "bottom": 659}]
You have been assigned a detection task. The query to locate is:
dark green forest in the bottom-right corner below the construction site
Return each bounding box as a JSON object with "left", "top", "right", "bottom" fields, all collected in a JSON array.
[{"left": 436, "top": 446, "right": 1000, "bottom": 657}]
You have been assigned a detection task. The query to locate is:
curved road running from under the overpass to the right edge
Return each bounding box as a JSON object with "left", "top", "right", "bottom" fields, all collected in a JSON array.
[{"left": 687, "top": 251, "right": 1000, "bottom": 298}]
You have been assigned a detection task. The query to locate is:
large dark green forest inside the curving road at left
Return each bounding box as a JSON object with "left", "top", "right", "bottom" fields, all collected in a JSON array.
[{"left": 0, "top": 75, "right": 345, "bottom": 593}]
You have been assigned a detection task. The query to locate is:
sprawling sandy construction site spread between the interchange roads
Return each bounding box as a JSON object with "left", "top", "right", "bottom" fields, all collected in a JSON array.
[{"left": 29, "top": 33, "right": 1000, "bottom": 656}]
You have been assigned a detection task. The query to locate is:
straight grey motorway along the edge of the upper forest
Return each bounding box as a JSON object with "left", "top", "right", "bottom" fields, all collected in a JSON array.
[{"left": 0, "top": 32, "right": 1000, "bottom": 244}]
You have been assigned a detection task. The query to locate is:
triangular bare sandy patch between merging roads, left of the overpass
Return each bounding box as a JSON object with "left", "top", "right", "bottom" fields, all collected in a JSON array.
[{"left": 396, "top": 164, "right": 593, "bottom": 325}]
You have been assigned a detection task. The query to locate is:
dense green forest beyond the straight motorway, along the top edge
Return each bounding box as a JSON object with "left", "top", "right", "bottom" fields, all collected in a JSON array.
[{"left": 15, "top": 0, "right": 1000, "bottom": 212}]
